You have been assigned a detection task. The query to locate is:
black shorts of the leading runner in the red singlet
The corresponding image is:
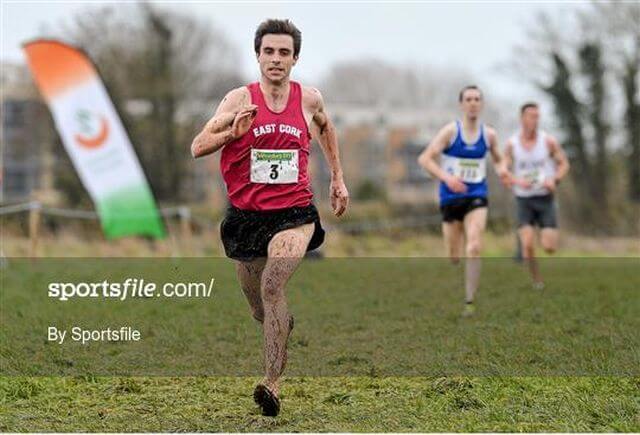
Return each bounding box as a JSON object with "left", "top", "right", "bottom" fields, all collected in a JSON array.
[{"left": 220, "top": 204, "right": 324, "bottom": 261}]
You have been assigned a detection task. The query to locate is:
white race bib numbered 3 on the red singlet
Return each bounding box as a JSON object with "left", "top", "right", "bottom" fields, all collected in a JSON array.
[{"left": 251, "top": 149, "right": 298, "bottom": 184}]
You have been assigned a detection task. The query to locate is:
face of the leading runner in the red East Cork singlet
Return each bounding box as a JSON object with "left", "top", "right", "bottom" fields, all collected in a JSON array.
[{"left": 258, "top": 34, "right": 298, "bottom": 83}]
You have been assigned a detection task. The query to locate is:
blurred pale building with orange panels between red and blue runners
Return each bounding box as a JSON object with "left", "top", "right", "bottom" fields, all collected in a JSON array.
[{"left": 312, "top": 105, "right": 455, "bottom": 205}]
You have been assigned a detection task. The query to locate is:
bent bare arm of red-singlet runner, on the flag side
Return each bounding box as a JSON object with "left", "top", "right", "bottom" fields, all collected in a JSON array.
[{"left": 191, "top": 87, "right": 257, "bottom": 158}]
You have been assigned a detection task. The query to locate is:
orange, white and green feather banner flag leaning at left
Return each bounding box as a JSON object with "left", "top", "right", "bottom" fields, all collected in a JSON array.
[{"left": 24, "top": 40, "right": 165, "bottom": 239}]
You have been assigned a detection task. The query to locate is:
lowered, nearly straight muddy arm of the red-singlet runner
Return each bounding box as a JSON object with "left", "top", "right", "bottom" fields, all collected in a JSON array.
[{"left": 304, "top": 88, "right": 349, "bottom": 216}]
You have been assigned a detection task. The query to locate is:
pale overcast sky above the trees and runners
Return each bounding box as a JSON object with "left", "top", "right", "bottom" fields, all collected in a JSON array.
[{"left": 0, "top": 0, "right": 577, "bottom": 99}]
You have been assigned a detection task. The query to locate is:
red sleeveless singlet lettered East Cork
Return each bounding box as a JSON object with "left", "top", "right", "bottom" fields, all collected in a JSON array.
[{"left": 220, "top": 81, "right": 313, "bottom": 210}]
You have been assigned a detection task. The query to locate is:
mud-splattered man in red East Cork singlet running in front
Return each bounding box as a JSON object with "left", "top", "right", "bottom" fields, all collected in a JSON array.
[{"left": 191, "top": 20, "right": 349, "bottom": 416}]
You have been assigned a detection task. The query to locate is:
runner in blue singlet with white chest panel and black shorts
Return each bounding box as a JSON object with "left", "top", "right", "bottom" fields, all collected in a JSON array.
[{"left": 418, "top": 86, "right": 510, "bottom": 317}]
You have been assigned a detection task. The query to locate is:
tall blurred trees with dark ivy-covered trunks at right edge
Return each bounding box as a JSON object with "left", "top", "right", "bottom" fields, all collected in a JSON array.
[{"left": 514, "top": 1, "right": 640, "bottom": 231}]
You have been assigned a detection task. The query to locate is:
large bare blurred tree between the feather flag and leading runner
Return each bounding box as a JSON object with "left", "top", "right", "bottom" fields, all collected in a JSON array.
[{"left": 54, "top": 3, "right": 243, "bottom": 201}]
